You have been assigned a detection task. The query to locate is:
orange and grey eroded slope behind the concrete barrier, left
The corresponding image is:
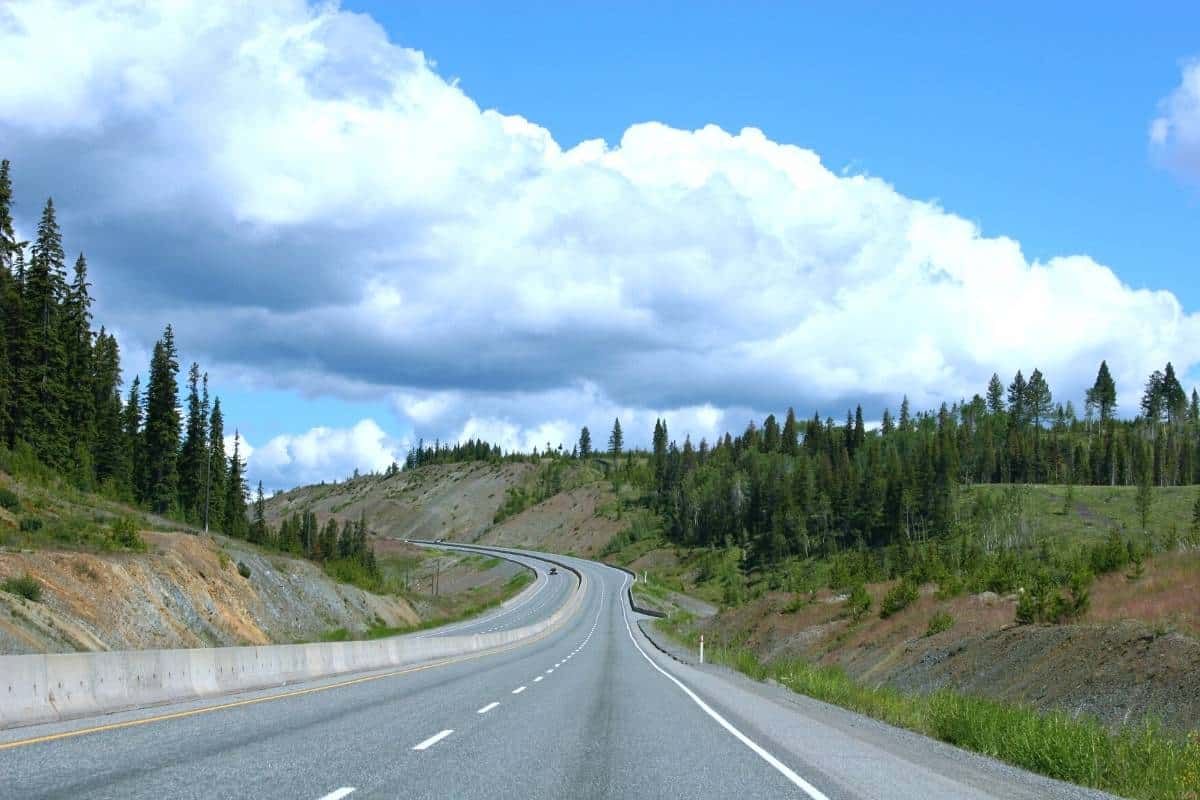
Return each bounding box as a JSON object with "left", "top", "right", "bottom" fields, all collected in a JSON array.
[{"left": 0, "top": 533, "right": 418, "bottom": 654}]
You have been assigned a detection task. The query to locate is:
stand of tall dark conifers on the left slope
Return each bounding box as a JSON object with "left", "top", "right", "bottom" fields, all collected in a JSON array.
[{"left": 0, "top": 155, "right": 248, "bottom": 537}]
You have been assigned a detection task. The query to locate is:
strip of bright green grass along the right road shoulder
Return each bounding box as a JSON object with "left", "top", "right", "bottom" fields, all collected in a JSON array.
[{"left": 658, "top": 614, "right": 1200, "bottom": 800}]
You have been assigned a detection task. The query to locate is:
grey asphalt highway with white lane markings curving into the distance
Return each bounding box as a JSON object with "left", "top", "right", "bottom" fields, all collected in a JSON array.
[{"left": 0, "top": 546, "right": 1118, "bottom": 800}]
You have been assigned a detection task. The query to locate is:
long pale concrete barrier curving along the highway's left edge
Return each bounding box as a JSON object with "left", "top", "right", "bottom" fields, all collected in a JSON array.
[{"left": 0, "top": 551, "right": 587, "bottom": 728}]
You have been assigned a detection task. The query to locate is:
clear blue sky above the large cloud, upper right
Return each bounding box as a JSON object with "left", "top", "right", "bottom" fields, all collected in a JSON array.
[{"left": 360, "top": 1, "right": 1200, "bottom": 303}]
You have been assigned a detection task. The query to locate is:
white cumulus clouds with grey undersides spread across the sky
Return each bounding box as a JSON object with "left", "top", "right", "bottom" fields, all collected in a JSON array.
[{"left": 0, "top": 0, "right": 1200, "bottom": 482}]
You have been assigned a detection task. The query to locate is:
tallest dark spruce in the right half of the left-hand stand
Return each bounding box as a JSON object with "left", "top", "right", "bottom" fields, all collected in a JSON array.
[{"left": 142, "top": 325, "right": 180, "bottom": 513}]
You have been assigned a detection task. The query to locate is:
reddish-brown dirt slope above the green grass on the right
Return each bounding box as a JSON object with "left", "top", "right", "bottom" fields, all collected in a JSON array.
[{"left": 686, "top": 553, "right": 1200, "bottom": 729}]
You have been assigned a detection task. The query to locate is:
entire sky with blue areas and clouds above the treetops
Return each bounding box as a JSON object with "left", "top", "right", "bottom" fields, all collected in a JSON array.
[{"left": 0, "top": 0, "right": 1200, "bottom": 488}]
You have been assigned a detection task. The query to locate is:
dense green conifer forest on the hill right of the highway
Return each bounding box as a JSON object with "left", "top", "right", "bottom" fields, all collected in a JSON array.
[{"left": 588, "top": 362, "right": 1200, "bottom": 573}]
